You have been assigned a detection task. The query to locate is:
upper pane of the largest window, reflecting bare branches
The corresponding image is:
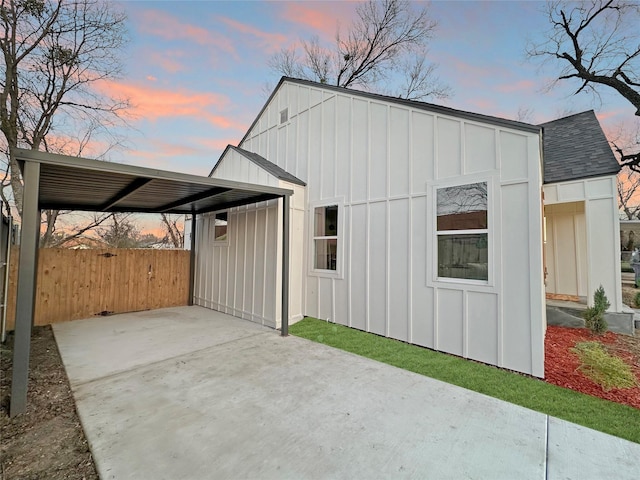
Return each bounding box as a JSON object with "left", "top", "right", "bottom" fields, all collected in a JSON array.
[{"left": 437, "top": 182, "right": 487, "bottom": 231}]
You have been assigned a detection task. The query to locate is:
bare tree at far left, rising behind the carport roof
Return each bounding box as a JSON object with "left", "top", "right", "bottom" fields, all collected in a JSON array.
[{"left": 0, "top": 0, "right": 128, "bottom": 218}]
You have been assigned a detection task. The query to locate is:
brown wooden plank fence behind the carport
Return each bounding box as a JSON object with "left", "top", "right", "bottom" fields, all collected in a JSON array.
[{"left": 7, "top": 248, "right": 189, "bottom": 330}]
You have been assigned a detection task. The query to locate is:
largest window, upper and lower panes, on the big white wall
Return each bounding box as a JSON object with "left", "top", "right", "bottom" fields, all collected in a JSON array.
[{"left": 436, "top": 182, "right": 489, "bottom": 281}]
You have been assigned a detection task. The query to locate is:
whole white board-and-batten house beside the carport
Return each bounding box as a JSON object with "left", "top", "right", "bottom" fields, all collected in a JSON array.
[{"left": 194, "top": 78, "right": 621, "bottom": 377}]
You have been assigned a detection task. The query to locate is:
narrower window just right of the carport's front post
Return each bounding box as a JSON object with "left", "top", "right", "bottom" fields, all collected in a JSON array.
[{"left": 313, "top": 205, "right": 338, "bottom": 271}]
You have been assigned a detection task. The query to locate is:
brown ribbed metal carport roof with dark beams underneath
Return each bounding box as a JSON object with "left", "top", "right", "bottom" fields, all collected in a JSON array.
[{"left": 15, "top": 149, "right": 293, "bottom": 214}]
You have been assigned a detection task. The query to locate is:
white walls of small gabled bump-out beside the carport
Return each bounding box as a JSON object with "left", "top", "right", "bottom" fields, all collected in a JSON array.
[{"left": 194, "top": 146, "right": 305, "bottom": 328}]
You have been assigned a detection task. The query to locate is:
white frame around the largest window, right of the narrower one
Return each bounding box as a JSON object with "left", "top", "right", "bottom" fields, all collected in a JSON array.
[{"left": 430, "top": 176, "right": 496, "bottom": 290}]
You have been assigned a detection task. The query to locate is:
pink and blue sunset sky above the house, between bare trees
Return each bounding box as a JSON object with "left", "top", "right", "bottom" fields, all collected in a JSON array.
[{"left": 100, "top": 1, "right": 633, "bottom": 175}]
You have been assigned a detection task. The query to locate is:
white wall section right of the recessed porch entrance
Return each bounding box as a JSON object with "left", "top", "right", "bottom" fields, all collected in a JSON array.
[{"left": 544, "top": 175, "right": 623, "bottom": 312}]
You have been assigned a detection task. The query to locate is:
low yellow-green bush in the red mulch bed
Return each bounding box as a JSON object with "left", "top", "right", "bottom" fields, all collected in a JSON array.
[{"left": 571, "top": 342, "right": 638, "bottom": 391}]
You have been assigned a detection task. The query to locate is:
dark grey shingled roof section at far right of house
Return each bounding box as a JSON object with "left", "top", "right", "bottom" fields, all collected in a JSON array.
[{"left": 540, "top": 110, "right": 620, "bottom": 183}]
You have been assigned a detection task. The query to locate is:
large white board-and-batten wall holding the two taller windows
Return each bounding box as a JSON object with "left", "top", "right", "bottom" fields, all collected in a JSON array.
[{"left": 241, "top": 82, "right": 545, "bottom": 376}]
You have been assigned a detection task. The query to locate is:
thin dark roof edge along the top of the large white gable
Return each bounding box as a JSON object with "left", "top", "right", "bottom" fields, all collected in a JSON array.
[{"left": 238, "top": 77, "right": 540, "bottom": 145}]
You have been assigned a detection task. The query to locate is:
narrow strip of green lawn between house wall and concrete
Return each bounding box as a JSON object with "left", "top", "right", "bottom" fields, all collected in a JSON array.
[{"left": 289, "top": 318, "right": 640, "bottom": 443}]
